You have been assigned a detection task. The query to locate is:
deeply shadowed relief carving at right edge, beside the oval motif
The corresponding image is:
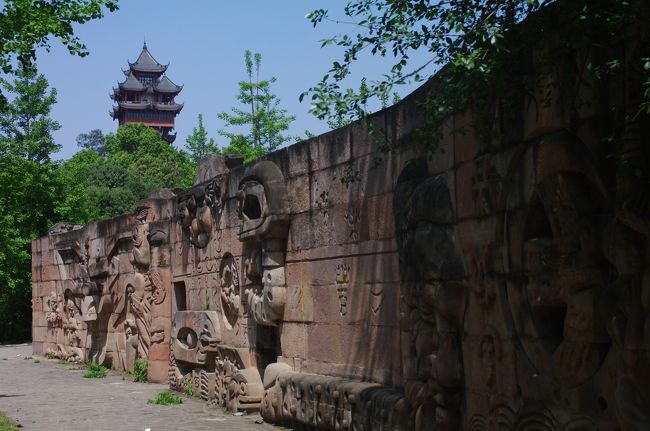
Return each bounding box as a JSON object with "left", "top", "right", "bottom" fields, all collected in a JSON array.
[{"left": 603, "top": 189, "right": 650, "bottom": 429}]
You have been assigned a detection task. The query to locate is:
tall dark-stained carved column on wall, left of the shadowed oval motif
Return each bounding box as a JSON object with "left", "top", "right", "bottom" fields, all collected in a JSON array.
[{"left": 393, "top": 160, "right": 466, "bottom": 430}]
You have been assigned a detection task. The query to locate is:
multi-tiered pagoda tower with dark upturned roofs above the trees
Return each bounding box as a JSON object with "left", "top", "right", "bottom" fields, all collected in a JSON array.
[{"left": 110, "top": 42, "right": 183, "bottom": 144}]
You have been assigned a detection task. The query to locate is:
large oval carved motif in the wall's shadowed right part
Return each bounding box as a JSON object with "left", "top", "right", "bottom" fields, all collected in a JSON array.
[{"left": 506, "top": 159, "right": 611, "bottom": 387}]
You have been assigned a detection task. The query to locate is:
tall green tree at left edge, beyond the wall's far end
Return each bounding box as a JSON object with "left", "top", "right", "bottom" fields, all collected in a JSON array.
[{"left": 0, "top": 68, "right": 60, "bottom": 341}]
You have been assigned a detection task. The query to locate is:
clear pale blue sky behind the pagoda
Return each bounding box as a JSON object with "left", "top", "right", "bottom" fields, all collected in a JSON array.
[{"left": 38, "top": 0, "right": 426, "bottom": 158}]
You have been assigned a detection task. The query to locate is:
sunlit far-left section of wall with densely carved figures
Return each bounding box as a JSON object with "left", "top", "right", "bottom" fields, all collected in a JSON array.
[{"left": 32, "top": 199, "right": 172, "bottom": 381}]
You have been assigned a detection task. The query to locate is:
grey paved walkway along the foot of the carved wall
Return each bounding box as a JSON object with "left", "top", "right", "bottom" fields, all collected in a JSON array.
[{"left": 0, "top": 344, "right": 274, "bottom": 431}]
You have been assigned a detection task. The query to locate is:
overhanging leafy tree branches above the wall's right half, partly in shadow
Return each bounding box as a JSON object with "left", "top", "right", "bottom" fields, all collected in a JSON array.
[{"left": 300, "top": 0, "right": 650, "bottom": 135}]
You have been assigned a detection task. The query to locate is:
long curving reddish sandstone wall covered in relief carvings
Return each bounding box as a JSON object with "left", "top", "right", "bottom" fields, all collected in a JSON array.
[{"left": 33, "top": 9, "right": 650, "bottom": 431}]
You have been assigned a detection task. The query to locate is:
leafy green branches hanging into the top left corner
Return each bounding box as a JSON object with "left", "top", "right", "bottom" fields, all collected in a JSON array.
[{"left": 0, "top": 0, "right": 118, "bottom": 107}]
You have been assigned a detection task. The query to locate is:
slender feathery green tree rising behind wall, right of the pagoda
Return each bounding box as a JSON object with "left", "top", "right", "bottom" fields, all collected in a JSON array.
[{"left": 217, "top": 50, "right": 296, "bottom": 162}]
